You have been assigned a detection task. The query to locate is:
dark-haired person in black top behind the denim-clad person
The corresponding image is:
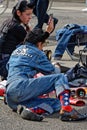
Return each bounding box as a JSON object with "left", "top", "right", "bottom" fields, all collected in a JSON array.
[{"left": 0, "top": 0, "right": 33, "bottom": 79}]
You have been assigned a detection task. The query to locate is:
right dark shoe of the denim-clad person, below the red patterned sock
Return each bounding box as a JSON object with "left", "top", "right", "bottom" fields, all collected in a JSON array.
[{"left": 59, "top": 109, "right": 87, "bottom": 121}]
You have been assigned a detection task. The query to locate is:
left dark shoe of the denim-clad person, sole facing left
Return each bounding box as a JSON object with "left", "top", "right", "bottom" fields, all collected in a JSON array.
[{"left": 17, "top": 105, "right": 44, "bottom": 121}]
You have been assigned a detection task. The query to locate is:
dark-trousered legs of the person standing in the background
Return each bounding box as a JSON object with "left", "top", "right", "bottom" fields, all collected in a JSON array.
[{"left": 30, "top": 0, "right": 58, "bottom": 28}]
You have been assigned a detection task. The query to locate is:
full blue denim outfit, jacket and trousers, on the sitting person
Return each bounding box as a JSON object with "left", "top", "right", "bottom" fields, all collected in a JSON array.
[{"left": 6, "top": 43, "right": 69, "bottom": 112}]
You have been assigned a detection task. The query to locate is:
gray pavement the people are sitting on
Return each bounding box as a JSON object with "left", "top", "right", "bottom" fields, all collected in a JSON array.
[{"left": 0, "top": 2, "right": 87, "bottom": 130}]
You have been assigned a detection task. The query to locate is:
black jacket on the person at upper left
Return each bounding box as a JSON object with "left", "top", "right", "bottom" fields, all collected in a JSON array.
[{"left": 0, "top": 19, "right": 27, "bottom": 54}]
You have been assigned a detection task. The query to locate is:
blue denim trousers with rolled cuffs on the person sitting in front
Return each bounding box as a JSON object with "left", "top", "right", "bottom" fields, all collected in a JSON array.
[{"left": 6, "top": 74, "right": 69, "bottom": 112}]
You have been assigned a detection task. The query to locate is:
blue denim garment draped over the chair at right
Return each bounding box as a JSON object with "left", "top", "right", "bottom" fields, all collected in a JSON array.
[{"left": 54, "top": 24, "right": 87, "bottom": 57}]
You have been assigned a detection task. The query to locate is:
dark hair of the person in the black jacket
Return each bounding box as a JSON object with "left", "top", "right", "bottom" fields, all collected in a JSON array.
[{"left": 12, "top": 0, "right": 34, "bottom": 21}]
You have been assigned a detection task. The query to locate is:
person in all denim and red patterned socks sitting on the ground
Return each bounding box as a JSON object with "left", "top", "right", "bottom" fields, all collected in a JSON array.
[{"left": 6, "top": 24, "right": 87, "bottom": 121}]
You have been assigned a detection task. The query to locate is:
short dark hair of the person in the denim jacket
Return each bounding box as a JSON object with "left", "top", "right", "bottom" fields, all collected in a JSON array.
[{"left": 24, "top": 28, "right": 48, "bottom": 44}]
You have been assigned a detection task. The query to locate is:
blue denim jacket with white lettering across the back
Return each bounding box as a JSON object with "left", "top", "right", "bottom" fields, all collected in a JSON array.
[{"left": 7, "top": 42, "right": 55, "bottom": 82}]
